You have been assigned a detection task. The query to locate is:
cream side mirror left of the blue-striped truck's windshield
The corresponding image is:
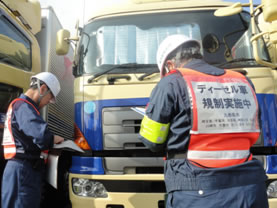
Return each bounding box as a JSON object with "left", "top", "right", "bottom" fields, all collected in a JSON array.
[{"left": 56, "top": 29, "right": 70, "bottom": 55}]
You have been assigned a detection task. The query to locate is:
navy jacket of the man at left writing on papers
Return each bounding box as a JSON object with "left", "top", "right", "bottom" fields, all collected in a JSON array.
[{"left": 11, "top": 94, "right": 54, "bottom": 158}]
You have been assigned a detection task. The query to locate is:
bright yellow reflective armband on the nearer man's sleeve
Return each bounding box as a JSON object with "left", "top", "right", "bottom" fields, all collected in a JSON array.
[{"left": 139, "top": 115, "right": 170, "bottom": 144}]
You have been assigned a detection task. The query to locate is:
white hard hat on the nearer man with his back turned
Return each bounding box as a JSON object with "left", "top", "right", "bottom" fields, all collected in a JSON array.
[{"left": 157, "top": 34, "right": 200, "bottom": 77}]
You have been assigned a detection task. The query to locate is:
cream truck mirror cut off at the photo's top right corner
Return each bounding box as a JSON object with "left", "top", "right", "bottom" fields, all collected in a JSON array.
[{"left": 262, "top": 0, "right": 277, "bottom": 22}]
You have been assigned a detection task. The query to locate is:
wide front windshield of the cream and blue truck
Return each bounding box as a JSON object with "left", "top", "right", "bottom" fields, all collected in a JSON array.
[{"left": 77, "top": 11, "right": 269, "bottom": 75}]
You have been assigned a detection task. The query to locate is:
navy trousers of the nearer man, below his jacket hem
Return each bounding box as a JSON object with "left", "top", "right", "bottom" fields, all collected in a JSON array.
[{"left": 166, "top": 183, "right": 268, "bottom": 208}]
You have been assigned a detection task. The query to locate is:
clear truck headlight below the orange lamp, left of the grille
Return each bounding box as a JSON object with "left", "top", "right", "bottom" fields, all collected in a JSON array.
[{"left": 72, "top": 178, "right": 108, "bottom": 198}]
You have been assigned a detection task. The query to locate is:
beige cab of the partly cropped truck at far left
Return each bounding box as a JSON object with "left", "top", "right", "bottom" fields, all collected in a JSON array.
[{"left": 0, "top": 0, "right": 41, "bottom": 206}]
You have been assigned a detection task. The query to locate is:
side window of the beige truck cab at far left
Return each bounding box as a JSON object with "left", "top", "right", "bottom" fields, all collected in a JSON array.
[{"left": 0, "top": 15, "right": 32, "bottom": 71}]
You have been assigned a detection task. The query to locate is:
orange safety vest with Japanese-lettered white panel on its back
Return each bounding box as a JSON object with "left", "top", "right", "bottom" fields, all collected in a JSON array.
[{"left": 178, "top": 68, "right": 260, "bottom": 168}]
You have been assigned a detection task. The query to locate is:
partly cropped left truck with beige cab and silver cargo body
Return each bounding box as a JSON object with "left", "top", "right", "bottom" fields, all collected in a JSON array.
[{"left": 0, "top": 0, "right": 74, "bottom": 206}]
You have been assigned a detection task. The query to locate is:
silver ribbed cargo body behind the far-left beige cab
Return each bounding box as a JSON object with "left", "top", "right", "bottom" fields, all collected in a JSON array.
[{"left": 36, "top": 7, "right": 74, "bottom": 139}]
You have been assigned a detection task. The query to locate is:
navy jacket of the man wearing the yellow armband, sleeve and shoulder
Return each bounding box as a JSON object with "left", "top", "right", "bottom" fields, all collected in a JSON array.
[{"left": 141, "top": 59, "right": 225, "bottom": 153}]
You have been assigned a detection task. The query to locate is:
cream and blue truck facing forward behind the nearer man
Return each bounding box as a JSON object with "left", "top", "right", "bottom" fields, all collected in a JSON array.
[{"left": 56, "top": 0, "right": 277, "bottom": 208}]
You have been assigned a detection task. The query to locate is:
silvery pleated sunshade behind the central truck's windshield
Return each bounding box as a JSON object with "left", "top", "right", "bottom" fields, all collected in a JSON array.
[{"left": 94, "top": 23, "right": 201, "bottom": 66}]
